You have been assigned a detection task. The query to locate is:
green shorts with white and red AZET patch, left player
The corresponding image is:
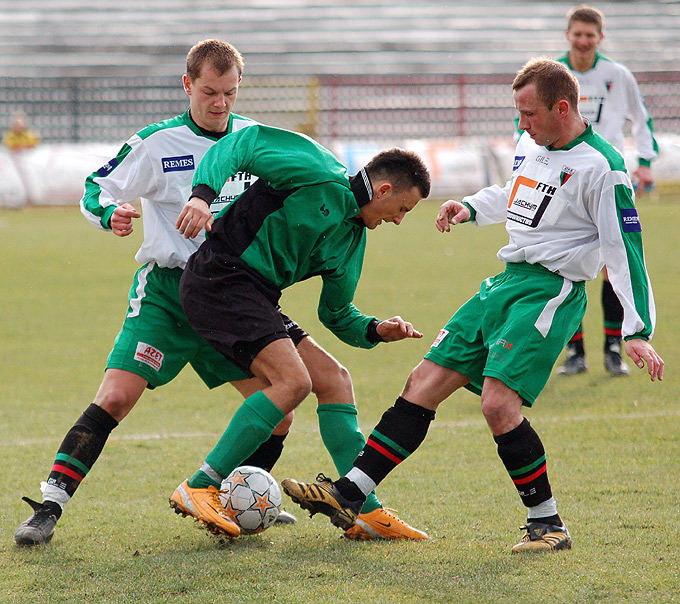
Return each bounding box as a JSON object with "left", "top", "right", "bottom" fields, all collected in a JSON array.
[{"left": 106, "top": 262, "right": 248, "bottom": 388}]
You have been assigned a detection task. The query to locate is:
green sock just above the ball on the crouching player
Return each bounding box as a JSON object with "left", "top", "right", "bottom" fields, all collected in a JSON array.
[{"left": 189, "top": 391, "right": 285, "bottom": 488}]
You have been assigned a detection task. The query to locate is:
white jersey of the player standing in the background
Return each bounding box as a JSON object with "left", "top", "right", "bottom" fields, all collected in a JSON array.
[{"left": 559, "top": 54, "right": 658, "bottom": 165}]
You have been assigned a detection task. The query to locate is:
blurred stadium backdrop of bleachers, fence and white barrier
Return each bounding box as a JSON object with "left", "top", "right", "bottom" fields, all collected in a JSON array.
[{"left": 0, "top": 0, "right": 680, "bottom": 205}]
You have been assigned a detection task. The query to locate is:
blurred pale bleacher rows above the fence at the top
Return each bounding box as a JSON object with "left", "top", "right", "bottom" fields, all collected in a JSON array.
[{"left": 0, "top": 0, "right": 680, "bottom": 77}]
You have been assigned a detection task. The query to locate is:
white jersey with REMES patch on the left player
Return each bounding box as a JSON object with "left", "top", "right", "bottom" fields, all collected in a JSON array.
[{"left": 80, "top": 110, "right": 257, "bottom": 268}]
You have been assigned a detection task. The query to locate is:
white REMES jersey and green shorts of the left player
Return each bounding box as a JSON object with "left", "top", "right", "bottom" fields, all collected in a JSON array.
[{"left": 80, "top": 110, "right": 257, "bottom": 388}]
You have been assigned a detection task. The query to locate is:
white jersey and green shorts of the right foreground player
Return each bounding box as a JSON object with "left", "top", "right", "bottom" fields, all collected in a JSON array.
[{"left": 427, "top": 126, "right": 656, "bottom": 404}]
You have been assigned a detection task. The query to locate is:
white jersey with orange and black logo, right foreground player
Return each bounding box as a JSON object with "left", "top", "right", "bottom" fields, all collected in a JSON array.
[{"left": 463, "top": 126, "right": 656, "bottom": 338}]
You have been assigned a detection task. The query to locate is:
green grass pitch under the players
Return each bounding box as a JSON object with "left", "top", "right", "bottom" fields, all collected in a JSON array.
[{"left": 0, "top": 192, "right": 680, "bottom": 604}]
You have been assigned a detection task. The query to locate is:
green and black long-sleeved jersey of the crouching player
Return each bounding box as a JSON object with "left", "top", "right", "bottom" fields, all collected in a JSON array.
[{"left": 193, "top": 125, "right": 375, "bottom": 348}]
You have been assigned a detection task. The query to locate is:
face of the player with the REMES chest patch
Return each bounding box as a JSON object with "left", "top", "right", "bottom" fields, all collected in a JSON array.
[{"left": 183, "top": 63, "right": 241, "bottom": 132}]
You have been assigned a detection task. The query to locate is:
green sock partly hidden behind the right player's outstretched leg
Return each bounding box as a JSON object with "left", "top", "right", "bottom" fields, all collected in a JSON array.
[{"left": 316, "top": 403, "right": 382, "bottom": 514}]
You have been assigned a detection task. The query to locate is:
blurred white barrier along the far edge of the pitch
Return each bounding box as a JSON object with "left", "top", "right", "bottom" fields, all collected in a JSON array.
[{"left": 0, "top": 135, "right": 680, "bottom": 208}]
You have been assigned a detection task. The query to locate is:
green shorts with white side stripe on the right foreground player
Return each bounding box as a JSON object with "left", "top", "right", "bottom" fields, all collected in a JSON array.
[{"left": 425, "top": 263, "right": 587, "bottom": 407}]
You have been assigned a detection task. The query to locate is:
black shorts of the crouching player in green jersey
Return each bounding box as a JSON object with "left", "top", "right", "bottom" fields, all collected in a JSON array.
[{"left": 180, "top": 244, "right": 307, "bottom": 375}]
